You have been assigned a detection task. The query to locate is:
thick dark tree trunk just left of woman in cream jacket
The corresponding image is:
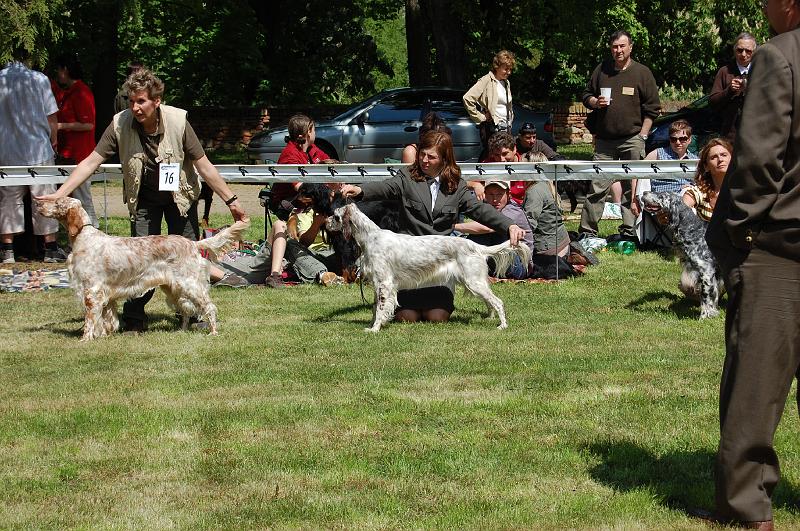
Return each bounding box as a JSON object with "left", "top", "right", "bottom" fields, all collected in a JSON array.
[{"left": 424, "top": 0, "right": 467, "bottom": 88}]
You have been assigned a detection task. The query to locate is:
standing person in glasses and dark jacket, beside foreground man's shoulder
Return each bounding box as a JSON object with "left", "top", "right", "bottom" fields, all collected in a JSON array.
[{"left": 709, "top": 33, "right": 756, "bottom": 142}]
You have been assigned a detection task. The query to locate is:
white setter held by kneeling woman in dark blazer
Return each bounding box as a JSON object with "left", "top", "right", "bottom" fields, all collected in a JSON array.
[{"left": 327, "top": 203, "right": 531, "bottom": 332}]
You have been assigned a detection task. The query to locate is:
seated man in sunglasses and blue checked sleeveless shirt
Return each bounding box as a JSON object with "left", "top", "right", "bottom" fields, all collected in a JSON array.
[{"left": 631, "top": 120, "right": 697, "bottom": 247}]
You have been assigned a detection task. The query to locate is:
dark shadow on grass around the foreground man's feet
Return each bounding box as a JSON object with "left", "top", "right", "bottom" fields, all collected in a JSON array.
[{"left": 584, "top": 441, "right": 800, "bottom": 512}]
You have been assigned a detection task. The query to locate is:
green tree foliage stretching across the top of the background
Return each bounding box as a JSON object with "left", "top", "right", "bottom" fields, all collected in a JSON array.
[{"left": 0, "top": 0, "right": 768, "bottom": 108}]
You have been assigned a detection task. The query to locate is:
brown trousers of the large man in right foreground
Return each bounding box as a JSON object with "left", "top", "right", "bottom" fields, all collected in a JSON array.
[{"left": 716, "top": 249, "right": 800, "bottom": 522}]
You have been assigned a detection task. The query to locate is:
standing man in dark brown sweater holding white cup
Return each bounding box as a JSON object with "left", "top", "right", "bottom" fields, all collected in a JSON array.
[{"left": 580, "top": 31, "right": 661, "bottom": 242}]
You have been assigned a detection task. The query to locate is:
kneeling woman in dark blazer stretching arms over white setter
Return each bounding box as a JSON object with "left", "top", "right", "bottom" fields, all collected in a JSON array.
[{"left": 342, "top": 131, "right": 525, "bottom": 322}]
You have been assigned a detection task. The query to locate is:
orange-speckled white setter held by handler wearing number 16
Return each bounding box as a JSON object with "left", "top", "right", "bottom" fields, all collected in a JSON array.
[{"left": 36, "top": 197, "right": 249, "bottom": 341}]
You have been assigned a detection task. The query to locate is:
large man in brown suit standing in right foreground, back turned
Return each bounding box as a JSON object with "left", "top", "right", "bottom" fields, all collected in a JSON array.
[{"left": 706, "top": 0, "right": 800, "bottom": 529}]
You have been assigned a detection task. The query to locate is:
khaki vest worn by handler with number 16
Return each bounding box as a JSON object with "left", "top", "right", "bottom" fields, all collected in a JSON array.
[{"left": 113, "top": 105, "right": 200, "bottom": 216}]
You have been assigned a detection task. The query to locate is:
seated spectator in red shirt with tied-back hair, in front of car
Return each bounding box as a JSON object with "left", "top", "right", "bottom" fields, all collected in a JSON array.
[{"left": 269, "top": 114, "right": 338, "bottom": 221}]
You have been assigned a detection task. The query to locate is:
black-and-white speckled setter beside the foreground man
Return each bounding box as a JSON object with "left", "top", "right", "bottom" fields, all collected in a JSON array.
[{"left": 642, "top": 191, "right": 724, "bottom": 319}]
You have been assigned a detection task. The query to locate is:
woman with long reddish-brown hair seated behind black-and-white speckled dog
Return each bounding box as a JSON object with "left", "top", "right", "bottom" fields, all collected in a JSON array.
[{"left": 683, "top": 138, "right": 733, "bottom": 222}]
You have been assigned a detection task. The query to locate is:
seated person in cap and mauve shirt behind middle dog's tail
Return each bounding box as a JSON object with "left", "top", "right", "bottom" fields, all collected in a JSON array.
[{"left": 454, "top": 180, "right": 533, "bottom": 279}]
